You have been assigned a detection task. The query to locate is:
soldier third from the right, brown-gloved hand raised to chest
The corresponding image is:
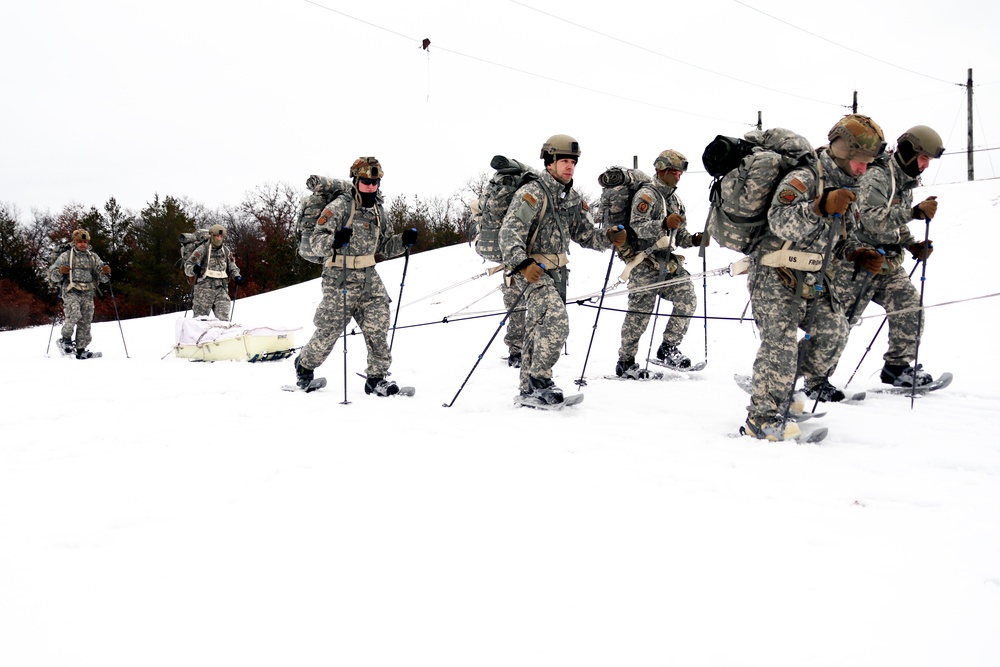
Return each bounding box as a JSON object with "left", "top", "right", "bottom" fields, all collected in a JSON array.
[{"left": 615, "top": 150, "right": 702, "bottom": 379}]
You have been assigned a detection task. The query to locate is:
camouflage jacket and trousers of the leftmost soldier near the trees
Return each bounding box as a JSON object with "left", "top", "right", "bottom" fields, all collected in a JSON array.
[{"left": 49, "top": 246, "right": 110, "bottom": 350}]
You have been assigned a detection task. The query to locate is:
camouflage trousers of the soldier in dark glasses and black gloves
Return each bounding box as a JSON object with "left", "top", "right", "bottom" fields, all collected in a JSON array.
[{"left": 299, "top": 267, "right": 392, "bottom": 377}]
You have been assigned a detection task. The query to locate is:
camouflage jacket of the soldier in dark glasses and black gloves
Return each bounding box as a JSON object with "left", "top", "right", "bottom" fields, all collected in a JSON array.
[{"left": 311, "top": 192, "right": 405, "bottom": 264}]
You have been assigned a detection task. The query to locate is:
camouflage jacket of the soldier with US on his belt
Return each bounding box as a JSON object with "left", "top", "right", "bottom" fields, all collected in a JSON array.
[{"left": 753, "top": 147, "right": 858, "bottom": 258}]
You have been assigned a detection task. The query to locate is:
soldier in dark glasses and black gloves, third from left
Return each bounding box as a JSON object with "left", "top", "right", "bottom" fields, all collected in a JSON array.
[{"left": 295, "top": 157, "right": 417, "bottom": 396}]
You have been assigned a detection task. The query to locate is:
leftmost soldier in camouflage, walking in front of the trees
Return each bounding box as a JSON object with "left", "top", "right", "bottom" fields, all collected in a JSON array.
[{"left": 49, "top": 229, "right": 111, "bottom": 359}]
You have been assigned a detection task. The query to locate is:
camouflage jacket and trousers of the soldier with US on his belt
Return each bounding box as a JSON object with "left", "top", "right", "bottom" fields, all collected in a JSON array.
[{"left": 747, "top": 148, "right": 857, "bottom": 423}]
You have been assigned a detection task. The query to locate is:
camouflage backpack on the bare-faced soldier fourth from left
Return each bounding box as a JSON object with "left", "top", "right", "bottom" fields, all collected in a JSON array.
[{"left": 467, "top": 155, "right": 548, "bottom": 262}]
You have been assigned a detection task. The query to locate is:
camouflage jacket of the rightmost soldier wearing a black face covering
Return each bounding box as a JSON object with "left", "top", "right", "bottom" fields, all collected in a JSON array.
[{"left": 844, "top": 156, "right": 920, "bottom": 269}]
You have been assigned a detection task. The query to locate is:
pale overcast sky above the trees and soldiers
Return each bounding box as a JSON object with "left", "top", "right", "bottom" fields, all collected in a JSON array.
[{"left": 0, "top": 0, "right": 1000, "bottom": 221}]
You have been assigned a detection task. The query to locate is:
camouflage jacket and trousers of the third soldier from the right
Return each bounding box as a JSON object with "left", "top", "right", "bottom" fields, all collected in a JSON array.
[{"left": 617, "top": 176, "right": 698, "bottom": 361}]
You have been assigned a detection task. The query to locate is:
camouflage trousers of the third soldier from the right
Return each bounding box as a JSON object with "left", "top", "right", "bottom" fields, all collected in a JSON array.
[{"left": 618, "top": 262, "right": 698, "bottom": 366}]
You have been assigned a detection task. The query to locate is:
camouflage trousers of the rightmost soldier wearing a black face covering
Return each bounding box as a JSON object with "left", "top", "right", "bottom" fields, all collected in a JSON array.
[{"left": 835, "top": 262, "right": 924, "bottom": 366}]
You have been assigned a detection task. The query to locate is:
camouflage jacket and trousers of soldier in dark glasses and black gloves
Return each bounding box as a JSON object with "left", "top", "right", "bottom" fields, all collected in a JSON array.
[{"left": 298, "top": 192, "right": 404, "bottom": 378}]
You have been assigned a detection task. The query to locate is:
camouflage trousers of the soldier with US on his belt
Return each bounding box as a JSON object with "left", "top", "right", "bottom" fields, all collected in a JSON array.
[{"left": 747, "top": 267, "right": 847, "bottom": 421}]
